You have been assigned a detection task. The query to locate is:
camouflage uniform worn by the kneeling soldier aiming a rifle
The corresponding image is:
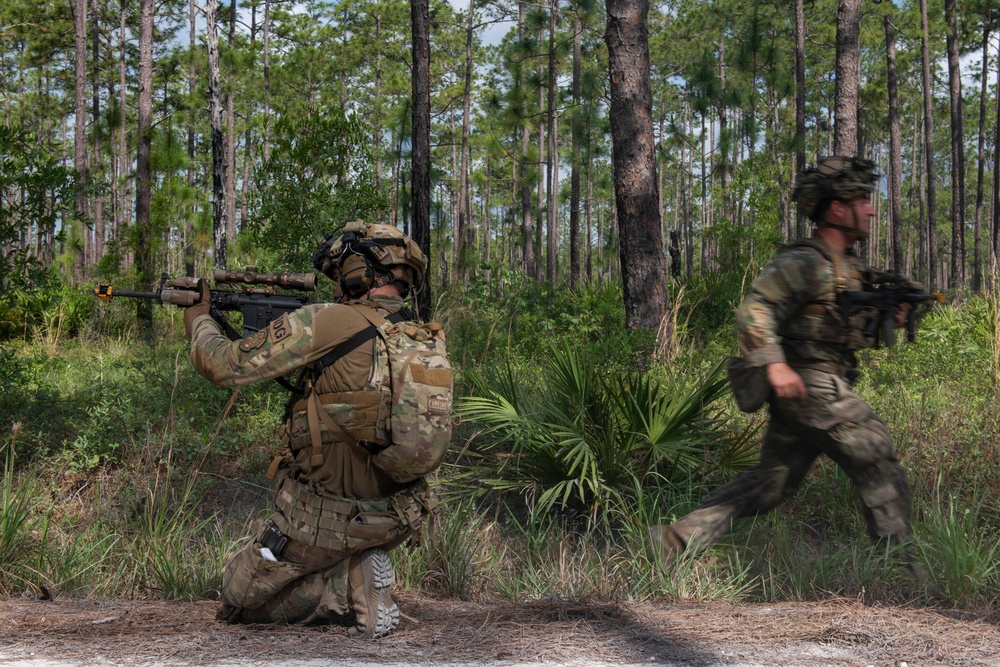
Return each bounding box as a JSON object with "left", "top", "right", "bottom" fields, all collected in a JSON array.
[{"left": 191, "top": 296, "right": 434, "bottom": 623}]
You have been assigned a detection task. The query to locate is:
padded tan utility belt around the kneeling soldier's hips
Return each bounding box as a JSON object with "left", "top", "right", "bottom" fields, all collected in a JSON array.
[{"left": 271, "top": 472, "right": 437, "bottom": 553}]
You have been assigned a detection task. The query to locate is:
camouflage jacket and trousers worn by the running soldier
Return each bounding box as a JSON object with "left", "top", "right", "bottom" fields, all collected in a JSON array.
[{"left": 661, "top": 236, "right": 910, "bottom": 548}]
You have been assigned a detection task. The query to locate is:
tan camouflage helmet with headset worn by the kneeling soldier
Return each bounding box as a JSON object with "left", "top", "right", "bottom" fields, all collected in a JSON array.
[{"left": 313, "top": 220, "right": 427, "bottom": 297}]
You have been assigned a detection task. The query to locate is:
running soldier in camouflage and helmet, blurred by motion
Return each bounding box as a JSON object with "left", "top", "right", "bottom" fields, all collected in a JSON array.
[{"left": 650, "top": 157, "right": 910, "bottom": 557}]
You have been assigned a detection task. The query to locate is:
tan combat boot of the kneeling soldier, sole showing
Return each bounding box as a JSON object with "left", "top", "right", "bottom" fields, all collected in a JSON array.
[{"left": 348, "top": 549, "right": 399, "bottom": 639}]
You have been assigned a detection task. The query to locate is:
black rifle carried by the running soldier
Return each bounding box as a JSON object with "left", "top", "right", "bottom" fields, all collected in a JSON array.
[{"left": 837, "top": 283, "right": 945, "bottom": 347}]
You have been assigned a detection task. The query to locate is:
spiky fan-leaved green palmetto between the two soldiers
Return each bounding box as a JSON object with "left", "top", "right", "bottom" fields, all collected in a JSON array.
[{"left": 460, "top": 345, "right": 726, "bottom": 516}]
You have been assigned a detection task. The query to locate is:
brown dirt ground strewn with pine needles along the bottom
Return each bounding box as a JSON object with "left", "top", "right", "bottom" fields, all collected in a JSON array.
[{"left": 0, "top": 591, "right": 1000, "bottom": 667}]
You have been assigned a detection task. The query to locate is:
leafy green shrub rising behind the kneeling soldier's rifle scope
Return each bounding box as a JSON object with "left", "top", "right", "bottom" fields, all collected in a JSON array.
[{"left": 249, "top": 107, "right": 386, "bottom": 271}]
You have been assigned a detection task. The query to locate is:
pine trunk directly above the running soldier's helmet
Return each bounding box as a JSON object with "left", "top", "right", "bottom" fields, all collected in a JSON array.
[{"left": 833, "top": 0, "right": 861, "bottom": 156}]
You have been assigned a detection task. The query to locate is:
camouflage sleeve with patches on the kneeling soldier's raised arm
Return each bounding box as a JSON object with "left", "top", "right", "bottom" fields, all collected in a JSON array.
[{"left": 191, "top": 304, "right": 376, "bottom": 387}]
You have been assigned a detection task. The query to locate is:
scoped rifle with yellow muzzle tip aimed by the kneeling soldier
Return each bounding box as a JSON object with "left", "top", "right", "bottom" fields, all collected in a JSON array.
[{"left": 94, "top": 266, "right": 316, "bottom": 340}]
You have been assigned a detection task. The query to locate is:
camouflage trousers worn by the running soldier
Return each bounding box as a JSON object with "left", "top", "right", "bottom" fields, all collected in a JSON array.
[{"left": 671, "top": 369, "right": 910, "bottom": 548}]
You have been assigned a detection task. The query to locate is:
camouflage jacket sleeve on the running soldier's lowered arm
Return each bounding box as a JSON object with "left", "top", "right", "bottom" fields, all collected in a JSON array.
[{"left": 736, "top": 247, "right": 836, "bottom": 366}]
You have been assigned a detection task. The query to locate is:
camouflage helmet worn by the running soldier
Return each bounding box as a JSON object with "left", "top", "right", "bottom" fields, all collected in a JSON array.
[{"left": 792, "top": 156, "right": 882, "bottom": 222}]
